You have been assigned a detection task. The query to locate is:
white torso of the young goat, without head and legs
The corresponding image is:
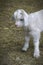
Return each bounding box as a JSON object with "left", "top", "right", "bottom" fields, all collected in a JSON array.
[{"left": 27, "top": 10, "right": 43, "bottom": 32}]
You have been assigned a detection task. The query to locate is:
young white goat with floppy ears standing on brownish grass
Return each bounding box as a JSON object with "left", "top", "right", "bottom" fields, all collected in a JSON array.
[{"left": 13, "top": 9, "right": 43, "bottom": 58}]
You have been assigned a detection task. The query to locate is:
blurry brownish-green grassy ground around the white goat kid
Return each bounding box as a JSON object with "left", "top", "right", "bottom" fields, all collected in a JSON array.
[{"left": 0, "top": 0, "right": 43, "bottom": 65}]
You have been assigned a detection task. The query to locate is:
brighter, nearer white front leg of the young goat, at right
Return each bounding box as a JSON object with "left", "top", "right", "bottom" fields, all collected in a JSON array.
[{"left": 33, "top": 32, "right": 40, "bottom": 58}]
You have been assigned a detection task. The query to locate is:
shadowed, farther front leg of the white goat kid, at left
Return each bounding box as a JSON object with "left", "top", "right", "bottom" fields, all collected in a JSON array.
[{"left": 22, "top": 27, "right": 30, "bottom": 51}]
